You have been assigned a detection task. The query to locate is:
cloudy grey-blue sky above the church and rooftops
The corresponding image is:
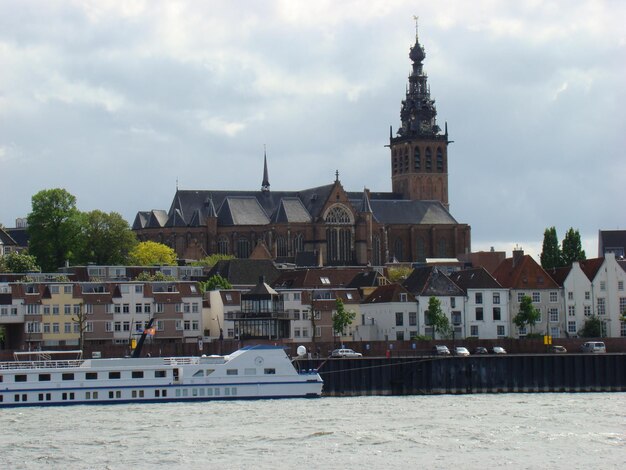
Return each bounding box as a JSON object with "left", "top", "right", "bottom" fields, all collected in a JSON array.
[{"left": 0, "top": 0, "right": 626, "bottom": 257}]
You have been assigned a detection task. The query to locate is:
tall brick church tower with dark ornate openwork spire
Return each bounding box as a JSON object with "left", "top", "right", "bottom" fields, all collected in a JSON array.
[{"left": 389, "top": 23, "right": 449, "bottom": 209}]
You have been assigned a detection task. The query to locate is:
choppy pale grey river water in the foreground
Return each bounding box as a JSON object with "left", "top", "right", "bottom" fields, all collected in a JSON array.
[{"left": 0, "top": 393, "right": 626, "bottom": 470}]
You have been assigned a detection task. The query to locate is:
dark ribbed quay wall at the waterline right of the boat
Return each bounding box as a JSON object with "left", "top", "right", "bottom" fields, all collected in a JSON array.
[{"left": 297, "top": 353, "right": 626, "bottom": 396}]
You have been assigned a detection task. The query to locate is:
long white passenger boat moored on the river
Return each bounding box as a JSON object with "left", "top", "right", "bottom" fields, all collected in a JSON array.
[{"left": 0, "top": 345, "right": 323, "bottom": 408}]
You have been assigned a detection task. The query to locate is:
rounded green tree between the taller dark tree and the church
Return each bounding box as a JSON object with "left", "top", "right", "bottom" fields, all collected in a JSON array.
[{"left": 77, "top": 210, "right": 137, "bottom": 265}]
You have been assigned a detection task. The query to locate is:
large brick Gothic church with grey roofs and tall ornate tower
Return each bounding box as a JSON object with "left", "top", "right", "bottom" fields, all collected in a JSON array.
[{"left": 133, "top": 27, "right": 471, "bottom": 266}]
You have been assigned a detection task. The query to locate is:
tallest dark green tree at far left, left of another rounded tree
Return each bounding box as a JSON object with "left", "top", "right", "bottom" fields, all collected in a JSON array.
[{"left": 28, "top": 188, "right": 80, "bottom": 272}]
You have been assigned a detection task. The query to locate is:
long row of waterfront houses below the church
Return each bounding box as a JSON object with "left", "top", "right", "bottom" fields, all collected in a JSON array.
[{"left": 0, "top": 250, "right": 626, "bottom": 349}]
